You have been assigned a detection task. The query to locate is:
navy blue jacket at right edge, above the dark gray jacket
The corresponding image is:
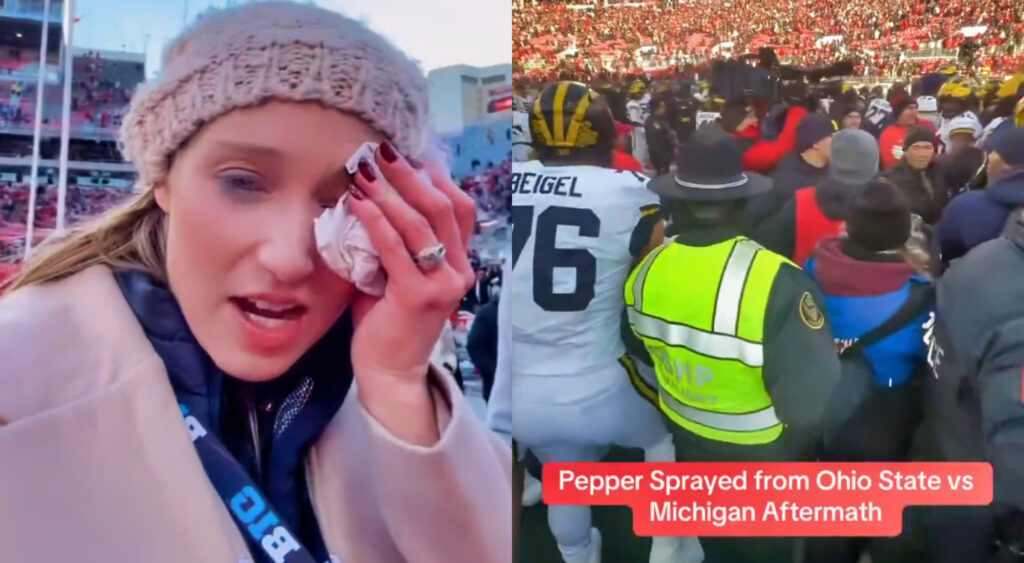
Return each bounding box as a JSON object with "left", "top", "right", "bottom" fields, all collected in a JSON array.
[{"left": 937, "top": 168, "right": 1024, "bottom": 262}]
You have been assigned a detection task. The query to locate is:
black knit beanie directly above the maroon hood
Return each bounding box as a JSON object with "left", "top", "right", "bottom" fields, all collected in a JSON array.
[{"left": 846, "top": 180, "right": 911, "bottom": 252}]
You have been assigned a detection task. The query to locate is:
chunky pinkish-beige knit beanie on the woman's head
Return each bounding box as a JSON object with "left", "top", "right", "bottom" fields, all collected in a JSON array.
[{"left": 120, "top": 1, "right": 430, "bottom": 188}]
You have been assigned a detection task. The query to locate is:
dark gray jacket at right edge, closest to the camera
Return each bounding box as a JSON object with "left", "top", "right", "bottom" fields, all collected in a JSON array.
[{"left": 919, "top": 219, "right": 1024, "bottom": 512}]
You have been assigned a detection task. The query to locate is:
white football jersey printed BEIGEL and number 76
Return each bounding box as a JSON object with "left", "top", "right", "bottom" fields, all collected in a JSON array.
[{"left": 502, "top": 161, "right": 658, "bottom": 376}]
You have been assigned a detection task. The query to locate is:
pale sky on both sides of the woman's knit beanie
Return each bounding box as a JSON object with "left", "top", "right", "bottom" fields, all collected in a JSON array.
[{"left": 74, "top": 0, "right": 512, "bottom": 77}]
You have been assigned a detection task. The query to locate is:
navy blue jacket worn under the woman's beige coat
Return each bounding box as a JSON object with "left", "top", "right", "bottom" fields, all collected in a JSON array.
[{"left": 115, "top": 271, "right": 352, "bottom": 563}]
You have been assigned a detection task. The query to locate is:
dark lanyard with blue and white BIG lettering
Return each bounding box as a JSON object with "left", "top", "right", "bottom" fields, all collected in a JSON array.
[{"left": 178, "top": 402, "right": 316, "bottom": 563}]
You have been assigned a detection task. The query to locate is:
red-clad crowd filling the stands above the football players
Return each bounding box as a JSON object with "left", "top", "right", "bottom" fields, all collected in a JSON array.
[{"left": 512, "top": 0, "right": 1024, "bottom": 80}]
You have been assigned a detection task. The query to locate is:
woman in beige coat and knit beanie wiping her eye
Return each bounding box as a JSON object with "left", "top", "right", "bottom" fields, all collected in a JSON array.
[{"left": 0, "top": 2, "right": 511, "bottom": 563}]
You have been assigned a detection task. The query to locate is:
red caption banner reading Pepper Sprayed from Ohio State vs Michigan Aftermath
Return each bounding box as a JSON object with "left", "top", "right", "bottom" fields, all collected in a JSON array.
[{"left": 544, "top": 463, "right": 992, "bottom": 536}]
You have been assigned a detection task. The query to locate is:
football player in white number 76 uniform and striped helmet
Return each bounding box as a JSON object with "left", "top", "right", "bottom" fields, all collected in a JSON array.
[{"left": 502, "top": 82, "right": 703, "bottom": 563}]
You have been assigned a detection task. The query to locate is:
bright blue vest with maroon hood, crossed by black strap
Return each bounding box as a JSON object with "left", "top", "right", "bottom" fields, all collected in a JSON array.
[{"left": 807, "top": 237, "right": 930, "bottom": 387}]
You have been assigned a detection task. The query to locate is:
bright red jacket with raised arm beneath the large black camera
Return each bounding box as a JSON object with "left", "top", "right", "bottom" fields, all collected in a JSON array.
[{"left": 721, "top": 100, "right": 807, "bottom": 174}]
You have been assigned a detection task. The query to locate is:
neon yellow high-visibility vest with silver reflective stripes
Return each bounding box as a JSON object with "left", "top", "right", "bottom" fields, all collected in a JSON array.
[{"left": 625, "top": 236, "right": 792, "bottom": 444}]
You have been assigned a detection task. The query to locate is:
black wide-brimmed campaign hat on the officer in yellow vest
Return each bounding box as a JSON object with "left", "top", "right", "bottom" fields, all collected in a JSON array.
[{"left": 648, "top": 125, "right": 772, "bottom": 202}]
